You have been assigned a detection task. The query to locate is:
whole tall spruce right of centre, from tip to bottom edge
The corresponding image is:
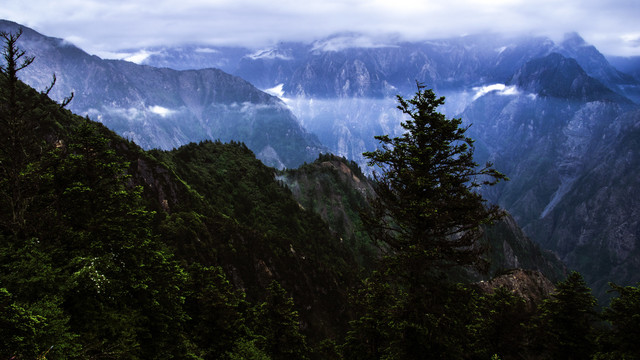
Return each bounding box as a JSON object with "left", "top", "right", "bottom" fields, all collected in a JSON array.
[{"left": 344, "top": 85, "right": 505, "bottom": 359}]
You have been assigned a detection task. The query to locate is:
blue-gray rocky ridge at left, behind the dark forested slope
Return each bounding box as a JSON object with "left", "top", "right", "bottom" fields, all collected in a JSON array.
[{"left": 0, "top": 22, "right": 326, "bottom": 168}]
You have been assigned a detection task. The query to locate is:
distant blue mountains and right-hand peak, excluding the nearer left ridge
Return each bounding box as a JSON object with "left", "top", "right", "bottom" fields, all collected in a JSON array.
[{"left": 135, "top": 33, "right": 640, "bottom": 295}]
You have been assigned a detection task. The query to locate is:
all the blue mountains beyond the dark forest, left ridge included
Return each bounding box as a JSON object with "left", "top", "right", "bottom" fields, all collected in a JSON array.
[{"left": 0, "top": 18, "right": 640, "bottom": 294}]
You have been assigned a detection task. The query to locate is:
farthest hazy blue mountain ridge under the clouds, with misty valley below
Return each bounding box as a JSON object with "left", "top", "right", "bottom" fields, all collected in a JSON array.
[{"left": 135, "top": 34, "right": 640, "bottom": 183}]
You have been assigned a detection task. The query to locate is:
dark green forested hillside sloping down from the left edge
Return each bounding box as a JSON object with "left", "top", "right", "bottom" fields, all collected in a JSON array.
[{"left": 0, "top": 30, "right": 357, "bottom": 359}]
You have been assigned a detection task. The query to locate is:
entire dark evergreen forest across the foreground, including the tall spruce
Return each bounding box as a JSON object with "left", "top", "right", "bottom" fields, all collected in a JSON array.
[{"left": 0, "top": 33, "right": 640, "bottom": 360}]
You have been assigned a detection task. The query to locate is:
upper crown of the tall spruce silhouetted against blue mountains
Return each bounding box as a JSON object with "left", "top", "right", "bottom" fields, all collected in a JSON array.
[{"left": 363, "top": 84, "right": 506, "bottom": 267}]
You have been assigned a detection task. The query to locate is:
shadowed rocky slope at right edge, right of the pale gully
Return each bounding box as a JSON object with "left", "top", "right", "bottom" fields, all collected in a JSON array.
[{"left": 530, "top": 111, "right": 640, "bottom": 294}]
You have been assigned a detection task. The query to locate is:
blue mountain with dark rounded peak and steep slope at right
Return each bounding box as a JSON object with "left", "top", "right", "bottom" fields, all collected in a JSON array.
[{"left": 462, "top": 54, "right": 640, "bottom": 296}]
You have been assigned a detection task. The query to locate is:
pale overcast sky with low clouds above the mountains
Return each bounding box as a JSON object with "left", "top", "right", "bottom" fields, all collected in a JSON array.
[{"left": 0, "top": 0, "right": 640, "bottom": 56}]
